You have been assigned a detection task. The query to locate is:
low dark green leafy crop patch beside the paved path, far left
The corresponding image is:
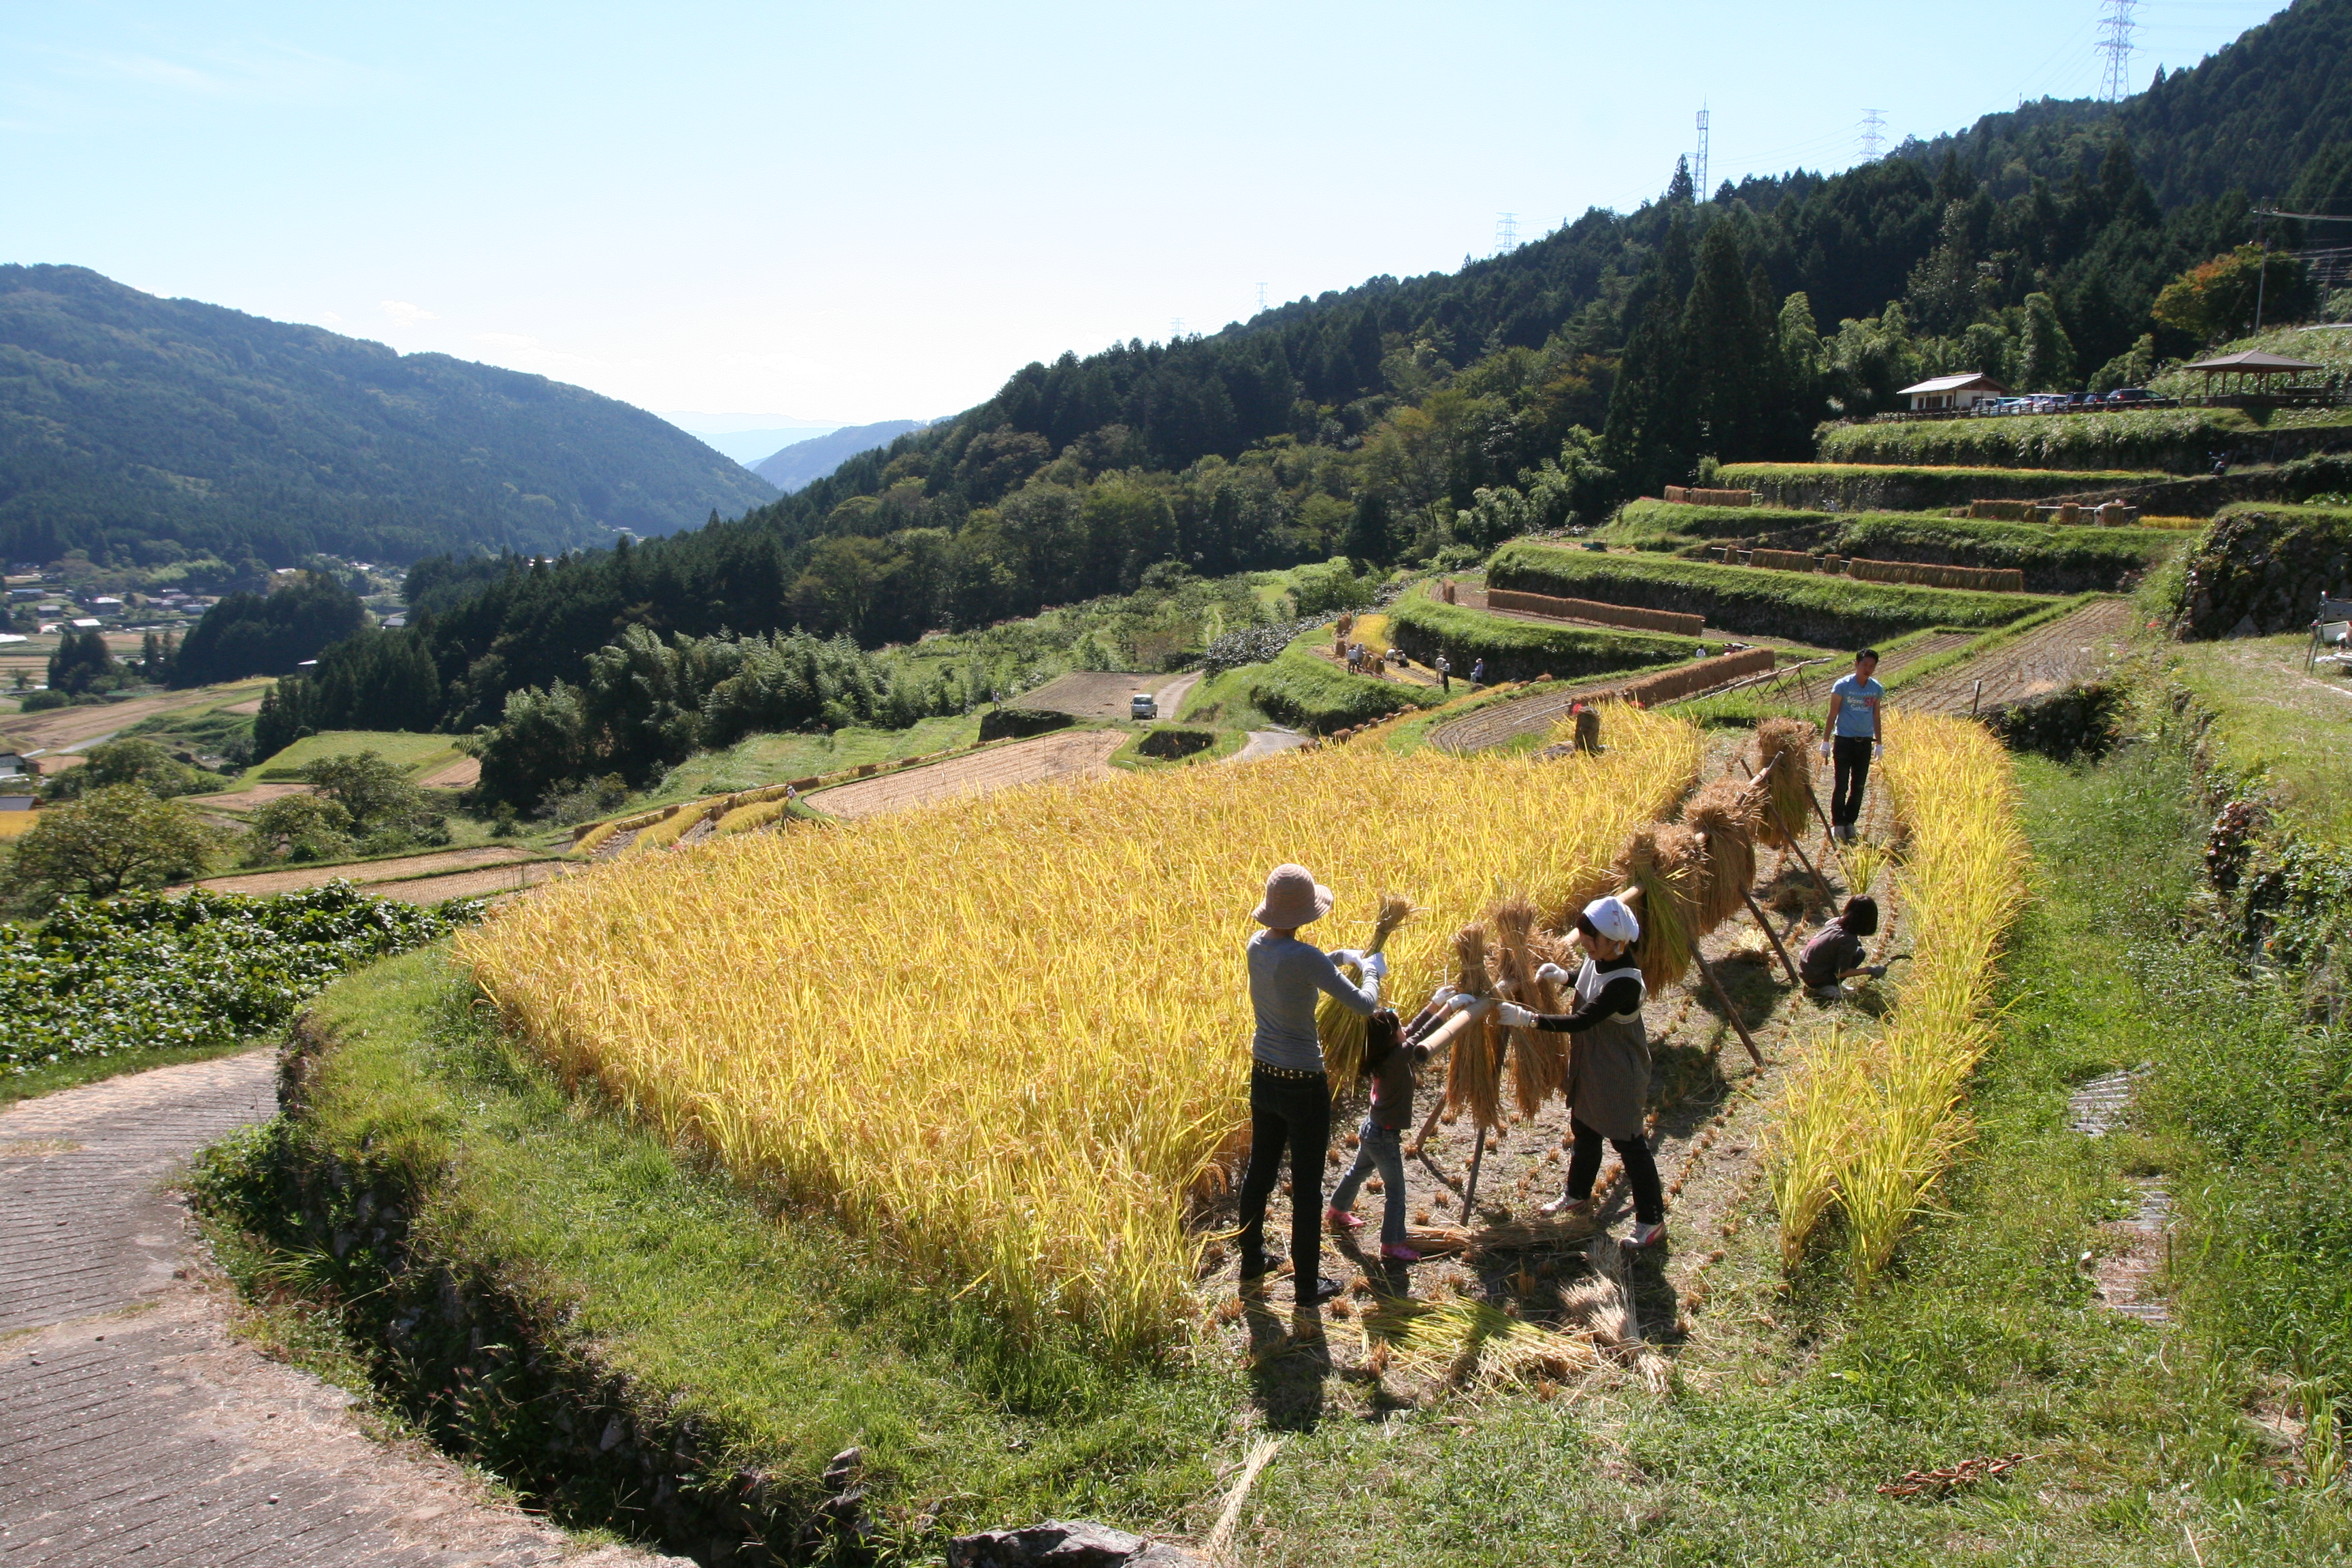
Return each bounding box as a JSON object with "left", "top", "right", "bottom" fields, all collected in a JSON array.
[{"left": 0, "top": 881, "right": 480, "bottom": 1072}]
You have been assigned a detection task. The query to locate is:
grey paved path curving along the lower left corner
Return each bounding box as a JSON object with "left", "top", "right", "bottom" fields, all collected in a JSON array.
[{"left": 0, "top": 1051, "right": 685, "bottom": 1568}]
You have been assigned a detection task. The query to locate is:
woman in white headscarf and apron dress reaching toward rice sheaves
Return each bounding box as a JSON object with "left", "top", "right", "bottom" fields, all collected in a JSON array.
[{"left": 1496, "top": 898, "right": 1665, "bottom": 1246}]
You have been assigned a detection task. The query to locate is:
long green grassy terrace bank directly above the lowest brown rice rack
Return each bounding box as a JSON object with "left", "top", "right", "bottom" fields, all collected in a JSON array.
[{"left": 1486, "top": 540, "right": 2044, "bottom": 647}]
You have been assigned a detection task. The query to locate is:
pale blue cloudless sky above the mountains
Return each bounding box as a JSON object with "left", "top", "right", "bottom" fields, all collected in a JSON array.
[{"left": 0, "top": 0, "right": 2276, "bottom": 428}]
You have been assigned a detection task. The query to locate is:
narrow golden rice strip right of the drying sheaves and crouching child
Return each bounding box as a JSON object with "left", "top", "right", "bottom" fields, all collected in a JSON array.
[{"left": 1769, "top": 713, "right": 2025, "bottom": 1284}]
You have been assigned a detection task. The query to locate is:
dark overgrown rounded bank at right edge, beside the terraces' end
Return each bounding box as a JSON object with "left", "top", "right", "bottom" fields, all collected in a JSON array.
[{"left": 2173, "top": 501, "right": 2352, "bottom": 637}]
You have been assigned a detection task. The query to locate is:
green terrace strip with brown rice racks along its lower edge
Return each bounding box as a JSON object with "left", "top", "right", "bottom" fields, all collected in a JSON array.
[{"left": 1599, "top": 498, "right": 2183, "bottom": 592}]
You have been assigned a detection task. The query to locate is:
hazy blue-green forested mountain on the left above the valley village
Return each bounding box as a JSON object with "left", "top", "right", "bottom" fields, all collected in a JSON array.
[{"left": 0, "top": 265, "right": 776, "bottom": 566}]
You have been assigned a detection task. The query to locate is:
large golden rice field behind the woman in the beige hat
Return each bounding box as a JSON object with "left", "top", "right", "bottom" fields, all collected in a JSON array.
[{"left": 459, "top": 710, "right": 1701, "bottom": 1359}]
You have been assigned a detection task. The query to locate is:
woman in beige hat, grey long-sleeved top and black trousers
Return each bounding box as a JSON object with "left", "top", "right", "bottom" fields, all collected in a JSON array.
[{"left": 1239, "top": 865, "right": 1388, "bottom": 1307}]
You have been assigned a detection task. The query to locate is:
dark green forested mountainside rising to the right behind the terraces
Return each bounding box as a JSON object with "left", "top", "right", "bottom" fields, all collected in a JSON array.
[{"left": 289, "top": 0, "right": 2352, "bottom": 780}]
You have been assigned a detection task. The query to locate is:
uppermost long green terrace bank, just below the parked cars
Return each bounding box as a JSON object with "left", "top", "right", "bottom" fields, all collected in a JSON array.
[{"left": 1818, "top": 409, "right": 2352, "bottom": 472}]
